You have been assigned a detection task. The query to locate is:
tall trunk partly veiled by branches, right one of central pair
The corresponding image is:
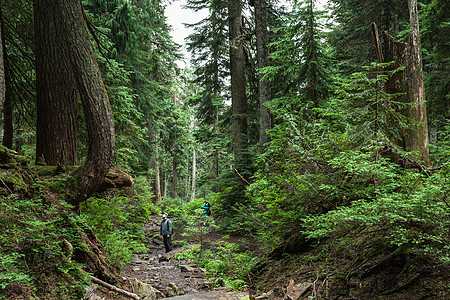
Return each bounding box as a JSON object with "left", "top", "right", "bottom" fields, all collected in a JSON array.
[{"left": 255, "top": 0, "right": 272, "bottom": 153}]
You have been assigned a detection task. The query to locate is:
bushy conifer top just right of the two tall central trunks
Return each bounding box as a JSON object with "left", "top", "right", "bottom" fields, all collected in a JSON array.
[{"left": 265, "top": 0, "right": 331, "bottom": 115}]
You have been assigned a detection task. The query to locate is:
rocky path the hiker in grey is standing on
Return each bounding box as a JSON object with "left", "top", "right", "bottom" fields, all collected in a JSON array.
[{"left": 86, "top": 218, "right": 253, "bottom": 300}]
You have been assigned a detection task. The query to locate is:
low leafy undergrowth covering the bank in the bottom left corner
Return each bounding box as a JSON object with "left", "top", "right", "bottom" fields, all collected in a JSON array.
[{"left": 0, "top": 193, "right": 88, "bottom": 299}]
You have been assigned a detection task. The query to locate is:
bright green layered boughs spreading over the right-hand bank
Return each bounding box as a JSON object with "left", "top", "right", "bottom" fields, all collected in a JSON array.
[{"left": 303, "top": 165, "right": 450, "bottom": 263}]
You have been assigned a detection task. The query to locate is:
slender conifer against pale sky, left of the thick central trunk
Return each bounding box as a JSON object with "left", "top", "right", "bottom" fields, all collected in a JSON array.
[{"left": 186, "top": 0, "right": 229, "bottom": 179}]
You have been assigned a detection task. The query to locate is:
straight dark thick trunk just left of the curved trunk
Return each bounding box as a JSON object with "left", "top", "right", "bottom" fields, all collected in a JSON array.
[{"left": 34, "top": 0, "right": 78, "bottom": 165}]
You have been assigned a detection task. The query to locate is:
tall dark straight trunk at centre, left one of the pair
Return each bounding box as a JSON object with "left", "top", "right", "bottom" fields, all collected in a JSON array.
[{"left": 228, "top": 0, "right": 247, "bottom": 161}]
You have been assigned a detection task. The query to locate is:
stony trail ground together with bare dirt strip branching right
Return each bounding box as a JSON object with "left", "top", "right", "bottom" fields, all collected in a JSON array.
[{"left": 92, "top": 217, "right": 260, "bottom": 300}]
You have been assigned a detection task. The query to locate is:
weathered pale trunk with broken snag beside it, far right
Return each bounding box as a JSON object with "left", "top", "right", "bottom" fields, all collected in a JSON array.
[{"left": 383, "top": 0, "right": 430, "bottom": 165}]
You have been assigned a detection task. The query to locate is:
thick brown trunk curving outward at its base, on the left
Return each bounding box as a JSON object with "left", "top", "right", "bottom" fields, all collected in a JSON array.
[{"left": 67, "top": 0, "right": 115, "bottom": 203}]
